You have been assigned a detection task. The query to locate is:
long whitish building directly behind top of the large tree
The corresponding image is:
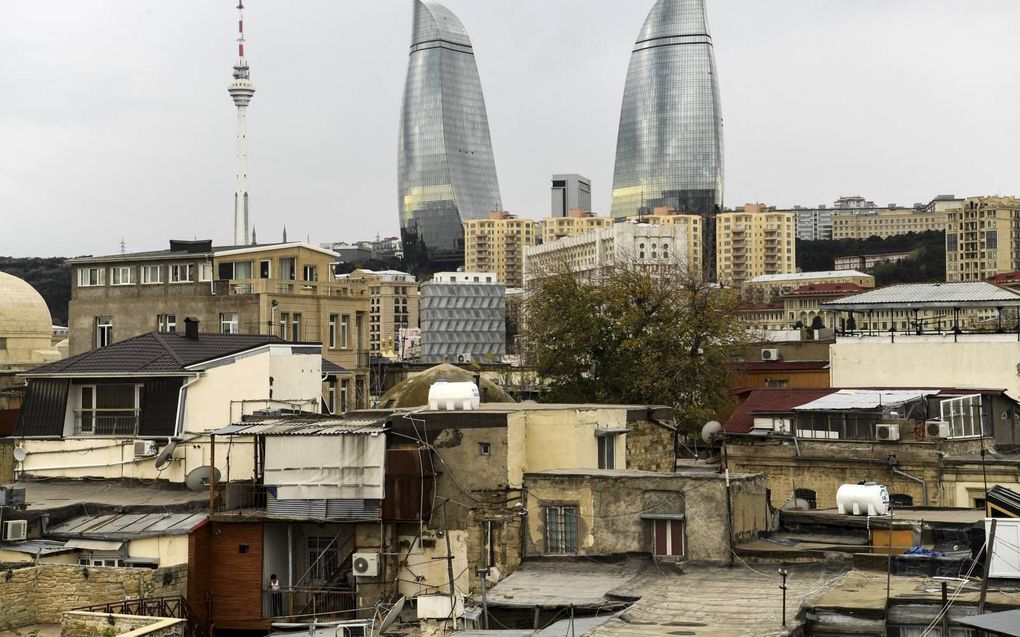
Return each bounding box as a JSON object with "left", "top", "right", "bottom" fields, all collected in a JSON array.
[{"left": 524, "top": 222, "right": 691, "bottom": 285}]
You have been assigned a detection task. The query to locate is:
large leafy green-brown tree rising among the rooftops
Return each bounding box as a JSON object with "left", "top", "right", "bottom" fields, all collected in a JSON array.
[{"left": 521, "top": 258, "right": 754, "bottom": 432}]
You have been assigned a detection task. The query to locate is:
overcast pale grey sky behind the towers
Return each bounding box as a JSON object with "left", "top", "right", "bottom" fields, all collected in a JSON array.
[{"left": 0, "top": 0, "right": 1020, "bottom": 256}]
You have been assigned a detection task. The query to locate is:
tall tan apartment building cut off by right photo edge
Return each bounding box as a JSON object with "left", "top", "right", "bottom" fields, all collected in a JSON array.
[{"left": 945, "top": 197, "right": 1020, "bottom": 282}]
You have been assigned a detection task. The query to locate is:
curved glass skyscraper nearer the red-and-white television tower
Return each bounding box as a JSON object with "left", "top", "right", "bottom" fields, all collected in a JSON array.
[{"left": 398, "top": 0, "right": 503, "bottom": 265}]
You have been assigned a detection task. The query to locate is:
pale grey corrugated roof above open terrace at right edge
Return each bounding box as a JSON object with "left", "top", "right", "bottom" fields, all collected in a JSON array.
[{"left": 821, "top": 281, "right": 1020, "bottom": 310}]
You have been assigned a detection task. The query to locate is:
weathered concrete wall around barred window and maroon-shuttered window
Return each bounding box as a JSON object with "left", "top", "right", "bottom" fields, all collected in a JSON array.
[{"left": 525, "top": 471, "right": 769, "bottom": 561}]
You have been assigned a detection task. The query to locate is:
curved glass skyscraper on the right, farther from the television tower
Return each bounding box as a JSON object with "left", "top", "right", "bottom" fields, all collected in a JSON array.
[{"left": 612, "top": 0, "right": 723, "bottom": 271}]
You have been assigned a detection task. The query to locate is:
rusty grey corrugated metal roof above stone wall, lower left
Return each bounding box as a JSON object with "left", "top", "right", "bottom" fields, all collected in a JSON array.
[{"left": 47, "top": 513, "right": 207, "bottom": 540}]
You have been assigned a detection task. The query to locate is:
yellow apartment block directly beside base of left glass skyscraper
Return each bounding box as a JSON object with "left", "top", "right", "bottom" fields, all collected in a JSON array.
[{"left": 464, "top": 212, "right": 539, "bottom": 287}]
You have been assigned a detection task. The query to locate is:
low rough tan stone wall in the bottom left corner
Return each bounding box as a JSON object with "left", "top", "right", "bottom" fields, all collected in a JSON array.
[{"left": 0, "top": 565, "right": 188, "bottom": 628}]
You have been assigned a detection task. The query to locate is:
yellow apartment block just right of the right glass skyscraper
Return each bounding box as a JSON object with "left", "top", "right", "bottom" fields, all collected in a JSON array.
[{"left": 715, "top": 204, "right": 797, "bottom": 285}]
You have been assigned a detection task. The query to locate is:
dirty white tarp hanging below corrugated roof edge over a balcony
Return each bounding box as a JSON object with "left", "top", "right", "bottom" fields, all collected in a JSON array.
[{"left": 265, "top": 434, "right": 386, "bottom": 499}]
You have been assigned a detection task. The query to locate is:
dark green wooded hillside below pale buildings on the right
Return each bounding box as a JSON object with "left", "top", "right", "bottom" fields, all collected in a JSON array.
[{"left": 797, "top": 230, "right": 946, "bottom": 285}]
